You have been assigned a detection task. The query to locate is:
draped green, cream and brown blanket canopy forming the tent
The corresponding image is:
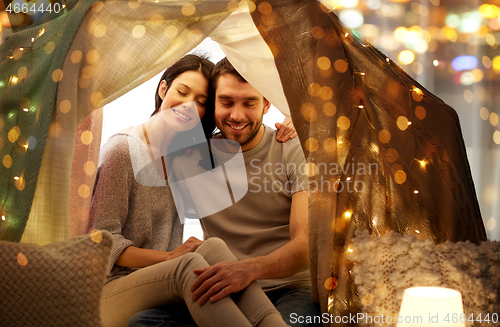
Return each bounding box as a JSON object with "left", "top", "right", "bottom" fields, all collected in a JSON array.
[{"left": 0, "top": 0, "right": 486, "bottom": 322}]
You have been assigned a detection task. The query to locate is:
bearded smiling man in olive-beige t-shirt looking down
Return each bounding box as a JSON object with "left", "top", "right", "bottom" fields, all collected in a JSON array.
[{"left": 129, "top": 58, "right": 320, "bottom": 327}]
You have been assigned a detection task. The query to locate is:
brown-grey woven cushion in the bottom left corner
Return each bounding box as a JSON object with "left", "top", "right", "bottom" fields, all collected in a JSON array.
[{"left": 0, "top": 231, "right": 113, "bottom": 327}]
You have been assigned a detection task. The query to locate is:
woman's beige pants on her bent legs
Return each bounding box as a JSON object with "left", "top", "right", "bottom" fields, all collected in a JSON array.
[{"left": 101, "top": 238, "right": 285, "bottom": 327}]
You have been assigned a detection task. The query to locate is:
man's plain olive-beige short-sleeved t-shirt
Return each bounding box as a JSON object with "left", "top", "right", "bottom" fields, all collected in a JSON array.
[{"left": 173, "top": 127, "right": 311, "bottom": 291}]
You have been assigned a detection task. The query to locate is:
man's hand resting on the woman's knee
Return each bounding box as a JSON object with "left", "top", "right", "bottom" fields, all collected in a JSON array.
[{"left": 191, "top": 260, "right": 254, "bottom": 305}]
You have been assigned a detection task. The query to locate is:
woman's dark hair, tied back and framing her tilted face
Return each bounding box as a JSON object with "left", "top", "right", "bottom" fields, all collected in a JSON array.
[{"left": 151, "top": 54, "right": 215, "bottom": 140}]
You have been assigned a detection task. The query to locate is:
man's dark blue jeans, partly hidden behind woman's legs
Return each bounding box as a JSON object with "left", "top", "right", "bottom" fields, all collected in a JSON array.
[{"left": 128, "top": 287, "right": 321, "bottom": 327}]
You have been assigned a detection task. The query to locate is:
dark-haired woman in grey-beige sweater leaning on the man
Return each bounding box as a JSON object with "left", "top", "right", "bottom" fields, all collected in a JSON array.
[{"left": 90, "top": 55, "right": 286, "bottom": 327}]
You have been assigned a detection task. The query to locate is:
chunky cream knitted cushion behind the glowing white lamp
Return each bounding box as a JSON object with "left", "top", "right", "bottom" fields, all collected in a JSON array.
[{"left": 347, "top": 230, "right": 500, "bottom": 326}]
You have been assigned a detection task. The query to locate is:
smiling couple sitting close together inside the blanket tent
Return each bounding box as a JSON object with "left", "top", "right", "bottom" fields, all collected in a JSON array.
[{"left": 91, "top": 55, "right": 319, "bottom": 327}]
